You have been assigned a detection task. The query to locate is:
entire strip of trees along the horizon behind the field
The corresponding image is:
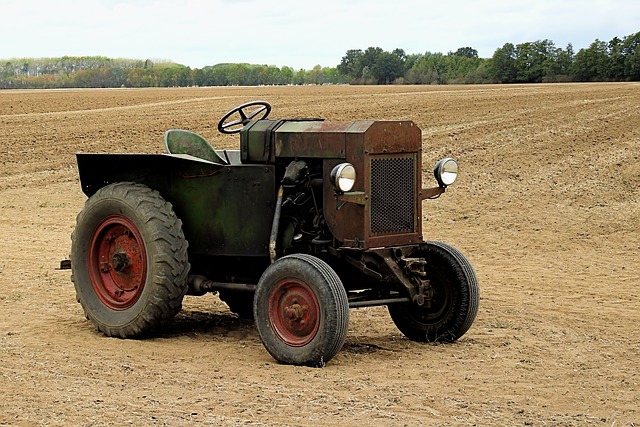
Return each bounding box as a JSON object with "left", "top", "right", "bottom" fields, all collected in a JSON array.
[{"left": 0, "top": 32, "right": 640, "bottom": 89}]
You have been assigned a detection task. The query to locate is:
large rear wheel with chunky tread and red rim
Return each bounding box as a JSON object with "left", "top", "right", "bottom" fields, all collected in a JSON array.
[{"left": 71, "top": 182, "right": 189, "bottom": 338}]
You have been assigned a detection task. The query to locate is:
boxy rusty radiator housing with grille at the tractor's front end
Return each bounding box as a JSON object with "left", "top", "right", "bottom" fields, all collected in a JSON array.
[{"left": 323, "top": 121, "right": 422, "bottom": 249}]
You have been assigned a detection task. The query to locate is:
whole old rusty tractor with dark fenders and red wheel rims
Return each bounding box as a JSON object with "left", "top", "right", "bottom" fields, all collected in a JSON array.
[{"left": 70, "top": 101, "right": 479, "bottom": 366}]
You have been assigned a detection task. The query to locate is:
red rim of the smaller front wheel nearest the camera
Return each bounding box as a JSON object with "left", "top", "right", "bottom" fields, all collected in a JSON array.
[{"left": 269, "top": 279, "right": 320, "bottom": 347}]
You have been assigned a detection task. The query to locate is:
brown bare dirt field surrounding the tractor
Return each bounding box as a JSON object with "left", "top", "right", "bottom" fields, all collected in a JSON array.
[{"left": 0, "top": 83, "right": 640, "bottom": 427}]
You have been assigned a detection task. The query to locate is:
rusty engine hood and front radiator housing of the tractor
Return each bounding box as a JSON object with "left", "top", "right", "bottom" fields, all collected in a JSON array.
[{"left": 241, "top": 120, "right": 422, "bottom": 249}]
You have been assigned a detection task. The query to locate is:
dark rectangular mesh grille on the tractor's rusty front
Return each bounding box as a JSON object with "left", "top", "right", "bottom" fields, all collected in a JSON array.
[{"left": 370, "top": 154, "right": 416, "bottom": 234}]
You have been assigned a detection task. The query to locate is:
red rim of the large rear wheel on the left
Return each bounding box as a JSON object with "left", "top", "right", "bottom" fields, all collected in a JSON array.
[{"left": 88, "top": 215, "right": 147, "bottom": 310}]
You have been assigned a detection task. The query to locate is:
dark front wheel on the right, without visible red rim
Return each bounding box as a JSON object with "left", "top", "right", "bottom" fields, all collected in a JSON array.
[{"left": 389, "top": 242, "right": 480, "bottom": 342}]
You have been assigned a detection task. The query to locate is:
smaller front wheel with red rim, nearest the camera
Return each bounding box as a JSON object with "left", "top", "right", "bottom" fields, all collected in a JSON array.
[{"left": 253, "top": 254, "right": 349, "bottom": 367}]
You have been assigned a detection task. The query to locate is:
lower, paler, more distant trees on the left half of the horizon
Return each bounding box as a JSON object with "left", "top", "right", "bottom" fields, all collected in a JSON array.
[{"left": 0, "top": 56, "right": 346, "bottom": 89}]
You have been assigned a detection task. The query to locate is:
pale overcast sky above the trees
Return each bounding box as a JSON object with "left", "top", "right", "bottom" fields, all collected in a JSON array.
[{"left": 0, "top": 0, "right": 640, "bottom": 70}]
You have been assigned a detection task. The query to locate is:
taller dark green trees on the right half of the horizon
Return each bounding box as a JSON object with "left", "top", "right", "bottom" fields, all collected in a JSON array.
[{"left": 337, "top": 32, "right": 640, "bottom": 84}]
